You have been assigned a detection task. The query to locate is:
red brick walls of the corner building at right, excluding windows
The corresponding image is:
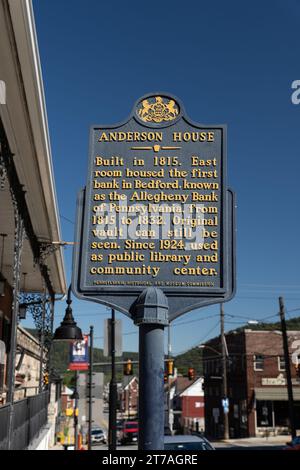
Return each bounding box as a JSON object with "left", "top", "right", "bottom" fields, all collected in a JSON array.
[{"left": 203, "top": 331, "right": 300, "bottom": 437}]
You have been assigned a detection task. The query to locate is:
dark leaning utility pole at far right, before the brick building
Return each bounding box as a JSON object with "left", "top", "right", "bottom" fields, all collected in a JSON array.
[{"left": 279, "top": 297, "right": 296, "bottom": 439}]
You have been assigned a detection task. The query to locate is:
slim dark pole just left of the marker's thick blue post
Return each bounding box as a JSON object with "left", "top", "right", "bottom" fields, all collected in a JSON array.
[{"left": 108, "top": 309, "right": 117, "bottom": 450}]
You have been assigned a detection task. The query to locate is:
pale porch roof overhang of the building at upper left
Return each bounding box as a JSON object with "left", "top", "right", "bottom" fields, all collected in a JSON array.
[{"left": 0, "top": 0, "right": 66, "bottom": 294}]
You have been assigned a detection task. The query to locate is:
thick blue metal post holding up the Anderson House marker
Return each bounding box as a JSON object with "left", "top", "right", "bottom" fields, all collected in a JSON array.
[{"left": 134, "top": 287, "right": 169, "bottom": 450}]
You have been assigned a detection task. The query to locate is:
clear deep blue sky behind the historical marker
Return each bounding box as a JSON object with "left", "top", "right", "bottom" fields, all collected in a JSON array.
[{"left": 21, "top": 0, "right": 300, "bottom": 353}]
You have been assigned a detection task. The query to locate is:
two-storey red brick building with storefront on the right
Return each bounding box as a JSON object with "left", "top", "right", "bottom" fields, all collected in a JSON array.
[{"left": 203, "top": 329, "right": 300, "bottom": 438}]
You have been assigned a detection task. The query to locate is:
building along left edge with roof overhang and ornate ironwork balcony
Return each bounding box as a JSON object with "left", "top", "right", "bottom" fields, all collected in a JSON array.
[{"left": 0, "top": 0, "right": 66, "bottom": 449}]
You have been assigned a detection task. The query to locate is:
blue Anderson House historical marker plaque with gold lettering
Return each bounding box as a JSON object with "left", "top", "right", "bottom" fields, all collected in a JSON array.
[{"left": 73, "top": 93, "right": 234, "bottom": 319}]
